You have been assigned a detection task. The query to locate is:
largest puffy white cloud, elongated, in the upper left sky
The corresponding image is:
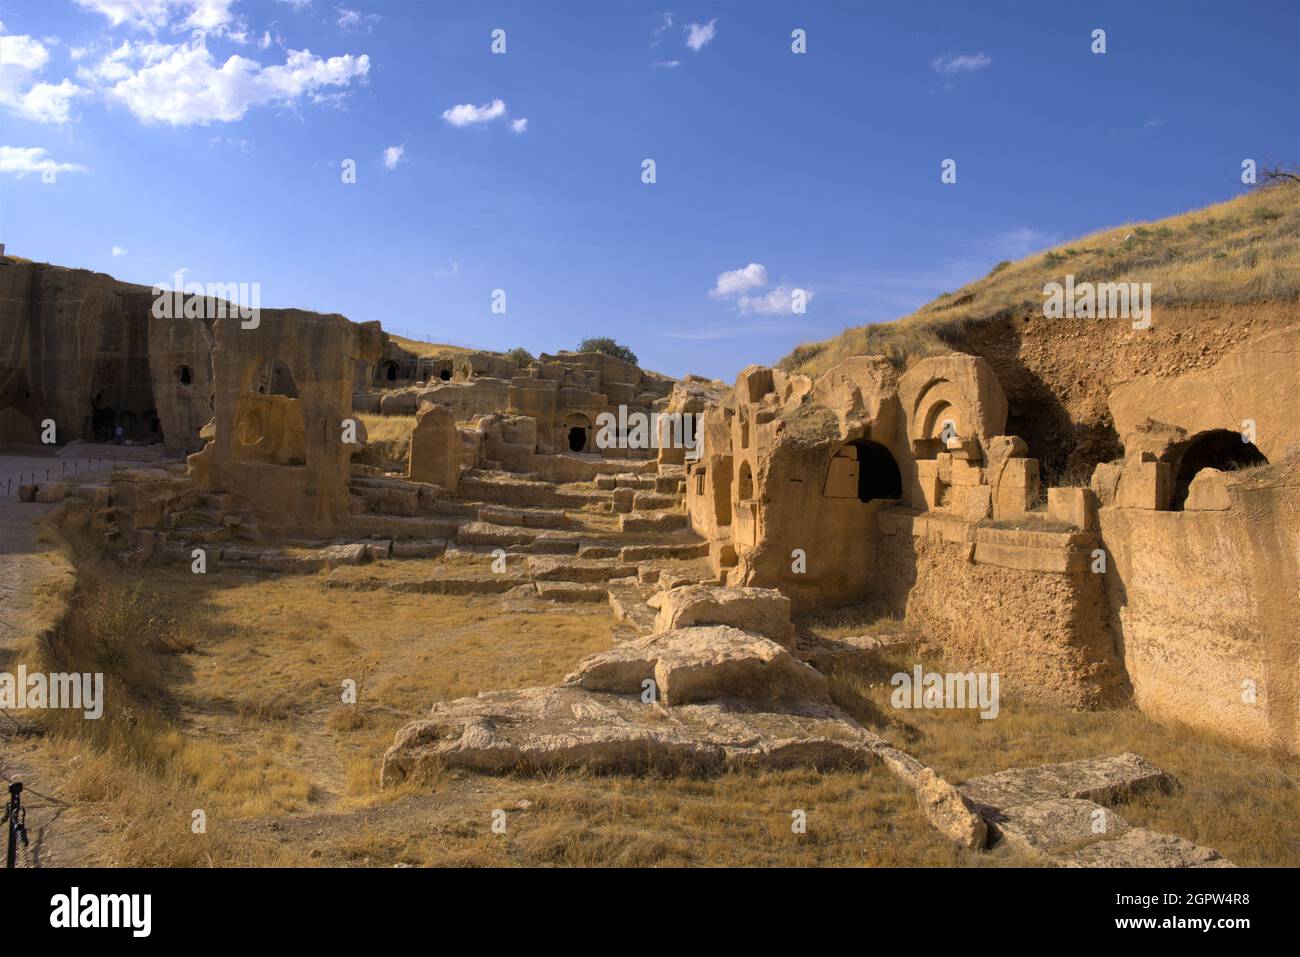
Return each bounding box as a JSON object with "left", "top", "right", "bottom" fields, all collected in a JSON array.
[{"left": 78, "top": 42, "right": 371, "bottom": 126}]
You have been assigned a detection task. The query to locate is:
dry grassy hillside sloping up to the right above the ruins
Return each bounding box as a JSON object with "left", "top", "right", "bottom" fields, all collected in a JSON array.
[{"left": 780, "top": 182, "right": 1300, "bottom": 374}]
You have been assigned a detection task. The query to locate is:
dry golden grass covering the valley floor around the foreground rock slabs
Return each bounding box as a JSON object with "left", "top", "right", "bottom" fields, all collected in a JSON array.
[{"left": 20, "top": 548, "right": 1300, "bottom": 866}]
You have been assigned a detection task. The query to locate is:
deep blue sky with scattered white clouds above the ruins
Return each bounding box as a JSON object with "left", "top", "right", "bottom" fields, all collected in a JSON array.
[{"left": 0, "top": 0, "right": 1300, "bottom": 380}]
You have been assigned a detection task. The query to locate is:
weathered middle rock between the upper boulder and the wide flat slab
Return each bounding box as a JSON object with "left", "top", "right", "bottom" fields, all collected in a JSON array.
[{"left": 564, "top": 624, "right": 831, "bottom": 710}]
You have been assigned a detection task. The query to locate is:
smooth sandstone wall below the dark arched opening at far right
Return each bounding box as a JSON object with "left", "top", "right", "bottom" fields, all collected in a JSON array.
[{"left": 1100, "top": 467, "right": 1300, "bottom": 753}]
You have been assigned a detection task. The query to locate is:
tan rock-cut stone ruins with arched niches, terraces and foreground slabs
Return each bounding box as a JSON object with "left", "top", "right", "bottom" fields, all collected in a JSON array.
[{"left": 0, "top": 256, "right": 1300, "bottom": 866}]
